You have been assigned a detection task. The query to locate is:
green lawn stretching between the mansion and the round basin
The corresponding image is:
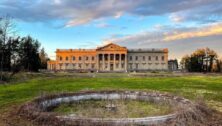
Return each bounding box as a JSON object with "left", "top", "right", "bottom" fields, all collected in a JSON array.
[{"left": 0, "top": 73, "right": 222, "bottom": 119}]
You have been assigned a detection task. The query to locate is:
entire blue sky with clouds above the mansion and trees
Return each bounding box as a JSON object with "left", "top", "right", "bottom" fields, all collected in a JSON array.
[{"left": 0, "top": 0, "right": 222, "bottom": 59}]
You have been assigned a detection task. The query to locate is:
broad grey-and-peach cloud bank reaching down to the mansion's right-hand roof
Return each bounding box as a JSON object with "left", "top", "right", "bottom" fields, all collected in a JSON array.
[{"left": 103, "top": 23, "right": 222, "bottom": 58}]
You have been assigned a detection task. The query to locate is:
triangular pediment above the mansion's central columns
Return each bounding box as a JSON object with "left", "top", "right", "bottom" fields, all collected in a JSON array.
[{"left": 97, "top": 43, "right": 127, "bottom": 51}]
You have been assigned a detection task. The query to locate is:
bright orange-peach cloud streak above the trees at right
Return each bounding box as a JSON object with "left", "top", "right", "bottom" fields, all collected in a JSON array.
[{"left": 163, "top": 24, "right": 222, "bottom": 41}]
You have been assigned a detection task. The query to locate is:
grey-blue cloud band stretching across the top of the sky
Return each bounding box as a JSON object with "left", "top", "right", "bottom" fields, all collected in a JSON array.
[{"left": 0, "top": 0, "right": 222, "bottom": 27}]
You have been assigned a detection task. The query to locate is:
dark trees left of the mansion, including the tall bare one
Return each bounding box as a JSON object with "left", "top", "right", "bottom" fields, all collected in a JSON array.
[{"left": 0, "top": 16, "right": 49, "bottom": 80}]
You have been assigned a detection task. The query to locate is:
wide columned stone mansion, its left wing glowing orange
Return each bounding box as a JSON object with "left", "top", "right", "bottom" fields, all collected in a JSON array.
[{"left": 47, "top": 43, "right": 168, "bottom": 72}]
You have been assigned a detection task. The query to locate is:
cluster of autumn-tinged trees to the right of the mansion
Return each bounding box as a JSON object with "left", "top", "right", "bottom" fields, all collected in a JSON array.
[{"left": 181, "top": 48, "right": 222, "bottom": 72}]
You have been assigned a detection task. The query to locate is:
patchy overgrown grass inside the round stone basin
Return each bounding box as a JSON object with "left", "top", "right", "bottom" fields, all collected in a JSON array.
[{"left": 53, "top": 100, "right": 173, "bottom": 118}]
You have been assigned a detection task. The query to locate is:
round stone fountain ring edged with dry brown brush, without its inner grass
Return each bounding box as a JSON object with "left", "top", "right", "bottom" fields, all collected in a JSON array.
[{"left": 19, "top": 91, "right": 202, "bottom": 126}]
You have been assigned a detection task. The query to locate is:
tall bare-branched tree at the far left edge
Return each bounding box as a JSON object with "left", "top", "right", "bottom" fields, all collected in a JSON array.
[{"left": 0, "top": 15, "right": 16, "bottom": 80}]
